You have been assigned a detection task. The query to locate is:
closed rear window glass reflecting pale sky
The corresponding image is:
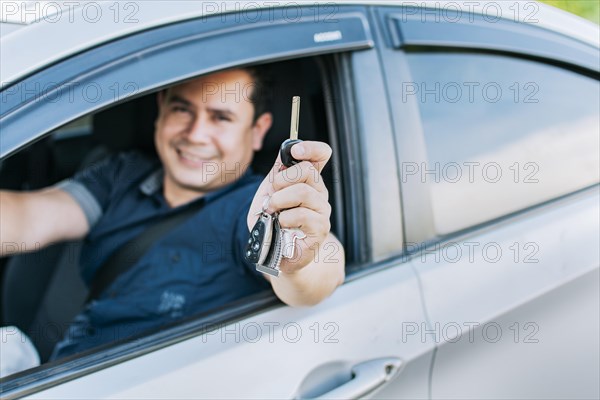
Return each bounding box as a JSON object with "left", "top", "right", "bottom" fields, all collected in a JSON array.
[{"left": 403, "top": 53, "right": 600, "bottom": 234}]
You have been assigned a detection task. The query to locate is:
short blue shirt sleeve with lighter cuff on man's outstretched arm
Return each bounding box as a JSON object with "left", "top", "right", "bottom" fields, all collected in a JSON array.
[{"left": 55, "top": 154, "right": 129, "bottom": 228}]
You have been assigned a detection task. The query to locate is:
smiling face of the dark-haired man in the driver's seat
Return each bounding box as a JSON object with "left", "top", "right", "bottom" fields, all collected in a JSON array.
[{"left": 155, "top": 70, "right": 271, "bottom": 203}]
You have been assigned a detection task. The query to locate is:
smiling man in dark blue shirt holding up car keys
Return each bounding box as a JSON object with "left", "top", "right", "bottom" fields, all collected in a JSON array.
[{"left": 0, "top": 68, "right": 344, "bottom": 358}]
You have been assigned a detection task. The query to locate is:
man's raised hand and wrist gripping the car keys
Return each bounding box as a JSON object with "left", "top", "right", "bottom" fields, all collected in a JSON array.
[{"left": 247, "top": 141, "right": 344, "bottom": 305}]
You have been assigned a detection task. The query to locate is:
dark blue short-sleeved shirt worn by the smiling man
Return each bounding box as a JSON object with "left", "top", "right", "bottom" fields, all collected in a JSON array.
[{"left": 52, "top": 152, "right": 270, "bottom": 358}]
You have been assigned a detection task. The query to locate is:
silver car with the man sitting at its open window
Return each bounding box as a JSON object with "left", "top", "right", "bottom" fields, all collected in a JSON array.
[{"left": 0, "top": 1, "right": 600, "bottom": 399}]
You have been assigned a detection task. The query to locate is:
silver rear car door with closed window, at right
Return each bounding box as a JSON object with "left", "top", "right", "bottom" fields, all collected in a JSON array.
[{"left": 377, "top": 3, "right": 600, "bottom": 398}]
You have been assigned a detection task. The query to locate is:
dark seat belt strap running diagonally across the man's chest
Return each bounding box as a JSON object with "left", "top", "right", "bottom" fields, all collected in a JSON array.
[{"left": 85, "top": 199, "right": 204, "bottom": 304}]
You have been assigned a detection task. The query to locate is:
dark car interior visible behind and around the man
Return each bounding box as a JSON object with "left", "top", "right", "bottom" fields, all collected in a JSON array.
[{"left": 0, "top": 58, "right": 343, "bottom": 363}]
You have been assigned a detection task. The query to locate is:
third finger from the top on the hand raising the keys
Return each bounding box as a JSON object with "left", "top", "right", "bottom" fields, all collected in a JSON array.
[{"left": 268, "top": 183, "right": 331, "bottom": 218}]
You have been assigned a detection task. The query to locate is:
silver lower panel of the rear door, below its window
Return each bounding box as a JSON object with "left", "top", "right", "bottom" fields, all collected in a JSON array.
[{"left": 422, "top": 187, "right": 600, "bottom": 399}]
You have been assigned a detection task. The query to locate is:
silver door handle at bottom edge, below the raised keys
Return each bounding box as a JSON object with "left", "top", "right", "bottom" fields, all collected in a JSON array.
[{"left": 310, "top": 357, "right": 402, "bottom": 400}]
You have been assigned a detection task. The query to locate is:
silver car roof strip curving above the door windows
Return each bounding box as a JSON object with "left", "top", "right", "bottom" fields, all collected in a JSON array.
[{"left": 0, "top": 0, "right": 600, "bottom": 87}]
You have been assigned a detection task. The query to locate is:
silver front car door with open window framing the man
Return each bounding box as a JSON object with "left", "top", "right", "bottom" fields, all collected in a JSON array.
[{"left": 0, "top": 2, "right": 434, "bottom": 399}]
